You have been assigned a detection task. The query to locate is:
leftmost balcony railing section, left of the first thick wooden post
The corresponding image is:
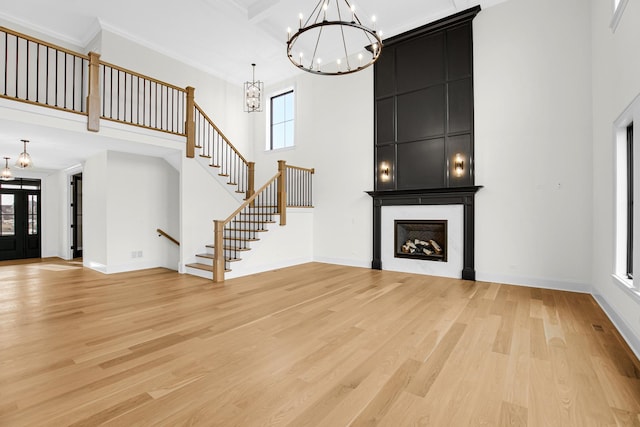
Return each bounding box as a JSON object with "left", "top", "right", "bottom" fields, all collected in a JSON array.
[{"left": 0, "top": 27, "right": 89, "bottom": 115}]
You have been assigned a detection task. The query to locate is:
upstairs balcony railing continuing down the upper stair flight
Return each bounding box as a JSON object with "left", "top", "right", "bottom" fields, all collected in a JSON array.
[{"left": 0, "top": 27, "right": 235, "bottom": 171}]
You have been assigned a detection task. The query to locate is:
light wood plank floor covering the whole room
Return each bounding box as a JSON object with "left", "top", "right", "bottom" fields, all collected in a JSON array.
[{"left": 0, "top": 260, "right": 640, "bottom": 427}]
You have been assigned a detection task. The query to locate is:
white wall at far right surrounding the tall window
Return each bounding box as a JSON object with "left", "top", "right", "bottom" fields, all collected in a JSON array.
[{"left": 591, "top": 0, "right": 640, "bottom": 354}]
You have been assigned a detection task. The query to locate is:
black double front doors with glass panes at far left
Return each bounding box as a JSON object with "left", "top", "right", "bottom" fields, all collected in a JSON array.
[{"left": 0, "top": 178, "right": 41, "bottom": 260}]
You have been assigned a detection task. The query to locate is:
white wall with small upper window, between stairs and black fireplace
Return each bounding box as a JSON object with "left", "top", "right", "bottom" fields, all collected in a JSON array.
[{"left": 248, "top": 68, "right": 373, "bottom": 267}]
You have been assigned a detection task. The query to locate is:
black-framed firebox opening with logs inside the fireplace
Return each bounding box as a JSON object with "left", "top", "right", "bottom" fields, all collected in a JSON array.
[{"left": 394, "top": 220, "right": 447, "bottom": 262}]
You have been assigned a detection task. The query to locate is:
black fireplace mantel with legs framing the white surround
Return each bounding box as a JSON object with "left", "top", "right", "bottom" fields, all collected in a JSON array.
[{"left": 367, "top": 186, "right": 482, "bottom": 280}]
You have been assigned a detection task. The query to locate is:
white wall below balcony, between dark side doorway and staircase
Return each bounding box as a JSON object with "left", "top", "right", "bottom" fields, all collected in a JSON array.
[{"left": 83, "top": 151, "right": 180, "bottom": 273}]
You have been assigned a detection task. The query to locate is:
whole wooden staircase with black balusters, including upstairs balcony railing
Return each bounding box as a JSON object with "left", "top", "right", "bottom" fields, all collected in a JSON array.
[{"left": 0, "top": 26, "right": 314, "bottom": 281}]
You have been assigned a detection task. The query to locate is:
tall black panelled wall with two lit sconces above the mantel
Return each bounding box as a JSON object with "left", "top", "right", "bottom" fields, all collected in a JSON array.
[{"left": 374, "top": 7, "right": 480, "bottom": 191}]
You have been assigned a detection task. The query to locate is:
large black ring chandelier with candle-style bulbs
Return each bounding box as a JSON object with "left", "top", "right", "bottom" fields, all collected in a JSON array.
[{"left": 287, "top": 0, "right": 382, "bottom": 76}]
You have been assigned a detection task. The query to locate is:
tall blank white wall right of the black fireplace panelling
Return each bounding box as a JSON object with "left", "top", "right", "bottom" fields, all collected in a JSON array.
[{"left": 473, "top": 0, "right": 592, "bottom": 292}]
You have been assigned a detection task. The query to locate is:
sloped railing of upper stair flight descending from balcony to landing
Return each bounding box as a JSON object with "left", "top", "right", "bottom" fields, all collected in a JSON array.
[{"left": 194, "top": 102, "right": 255, "bottom": 199}]
